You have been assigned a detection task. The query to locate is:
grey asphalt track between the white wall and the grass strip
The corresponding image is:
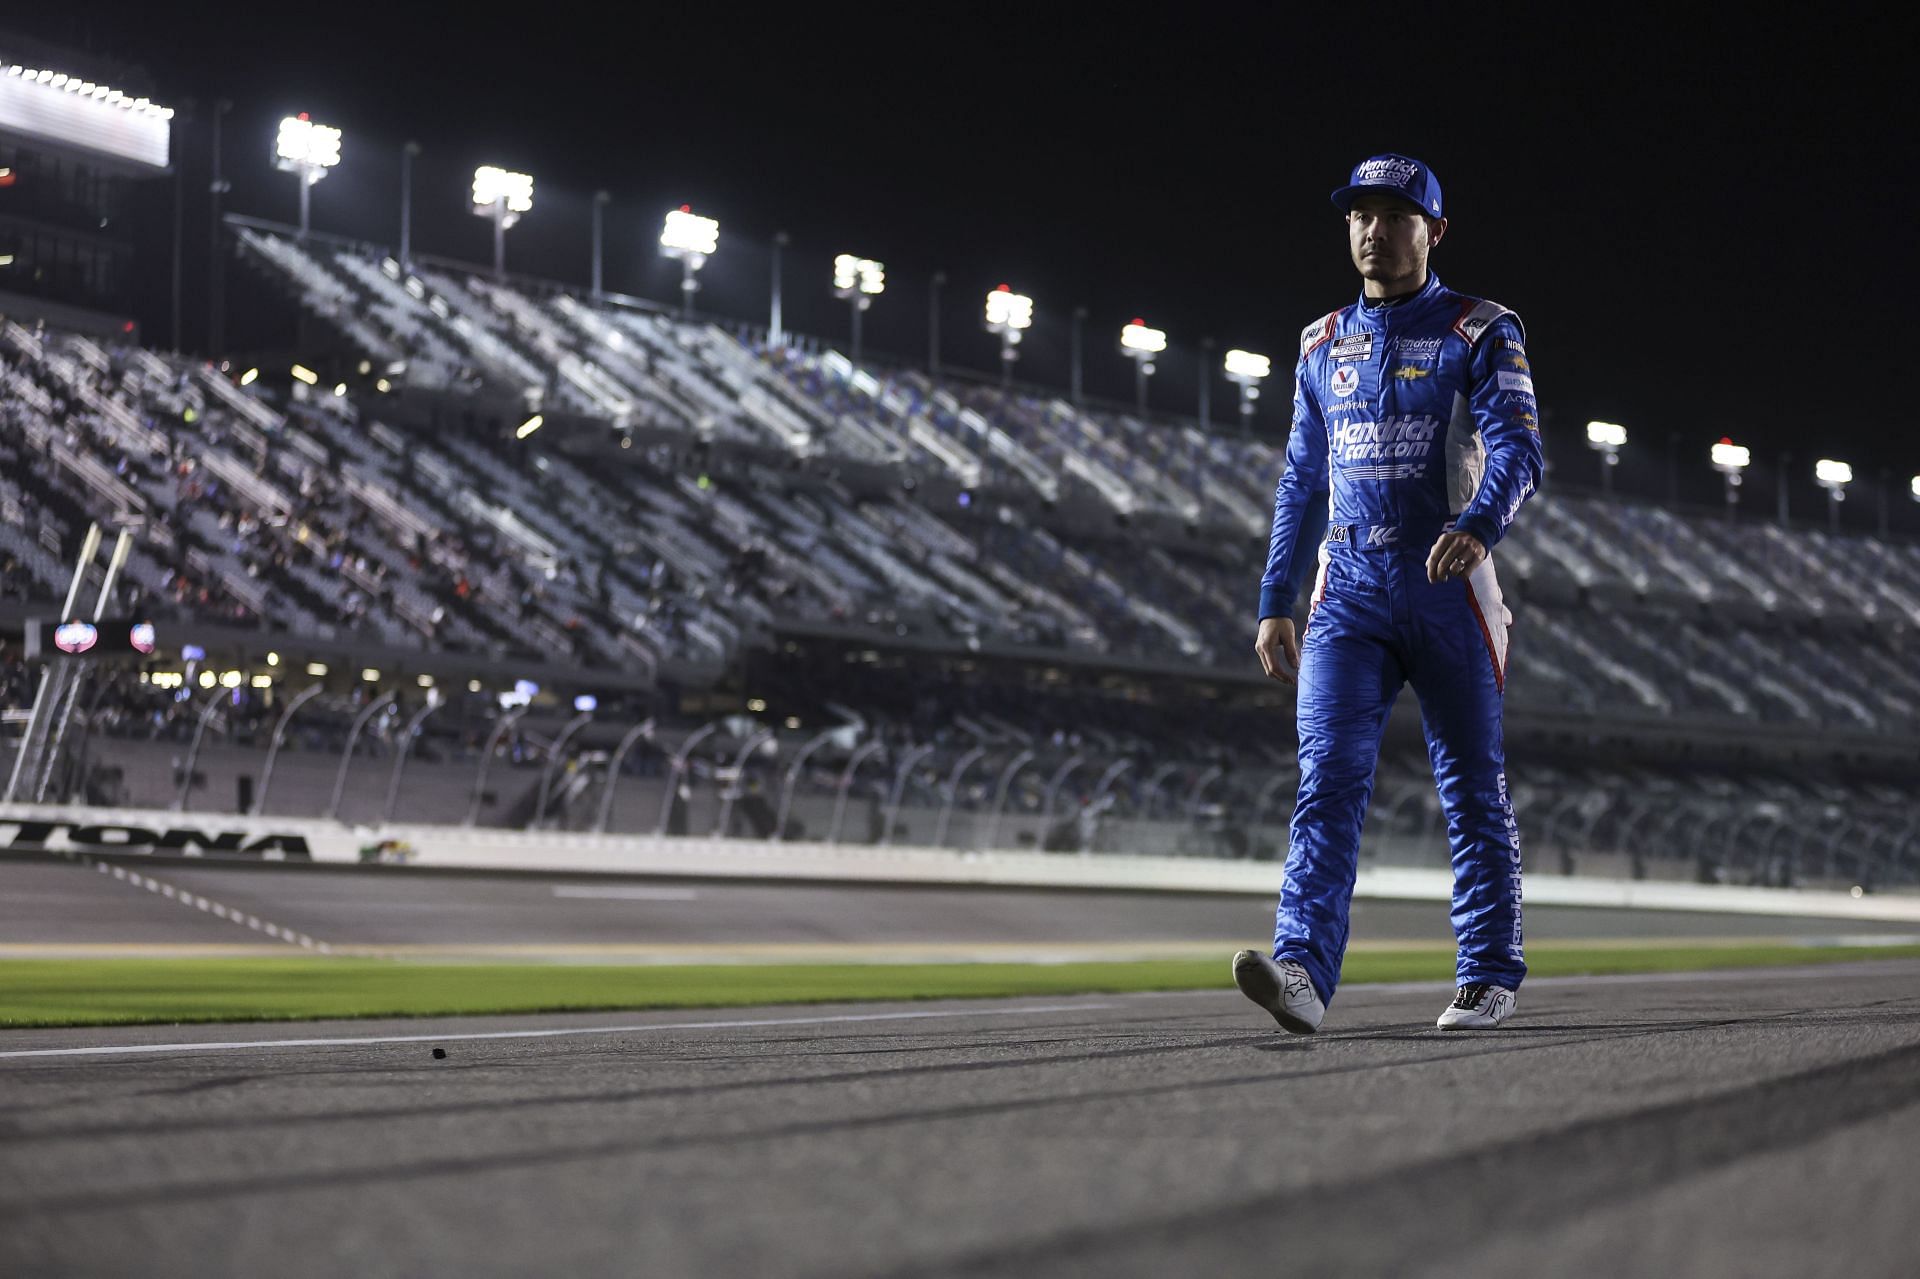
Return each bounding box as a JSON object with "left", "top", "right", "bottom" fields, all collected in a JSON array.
[{"left": 0, "top": 857, "right": 1920, "bottom": 962}]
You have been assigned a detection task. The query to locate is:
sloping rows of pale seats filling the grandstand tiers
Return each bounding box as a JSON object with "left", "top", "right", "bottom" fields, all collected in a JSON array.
[{"left": 0, "top": 229, "right": 1920, "bottom": 876}]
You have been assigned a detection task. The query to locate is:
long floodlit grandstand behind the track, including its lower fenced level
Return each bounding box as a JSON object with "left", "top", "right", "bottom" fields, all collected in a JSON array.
[{"left": 0, "top": 219, "right": 1920, "bottom": 887}]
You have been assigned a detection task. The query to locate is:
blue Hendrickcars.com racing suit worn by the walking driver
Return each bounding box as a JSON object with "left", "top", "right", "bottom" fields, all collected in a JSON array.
[{"left": 1260, "top": 275, "right": 1542, "bottom": 999}]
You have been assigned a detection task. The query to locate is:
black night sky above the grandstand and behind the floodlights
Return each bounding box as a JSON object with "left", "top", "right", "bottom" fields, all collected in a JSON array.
[{"left": 8, "top": 4, "right": 1920, "bottom": 519}]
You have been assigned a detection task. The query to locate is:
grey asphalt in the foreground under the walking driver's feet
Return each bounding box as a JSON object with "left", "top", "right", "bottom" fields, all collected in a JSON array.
[{"left": 0, "top": 956, "right": 1920, "bottom": 1279}]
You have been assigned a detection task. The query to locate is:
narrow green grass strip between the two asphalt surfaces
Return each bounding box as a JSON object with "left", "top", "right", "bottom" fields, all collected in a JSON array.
[{"left": 0, "top": 943, "right": 1920, "bottom": 1027}]
